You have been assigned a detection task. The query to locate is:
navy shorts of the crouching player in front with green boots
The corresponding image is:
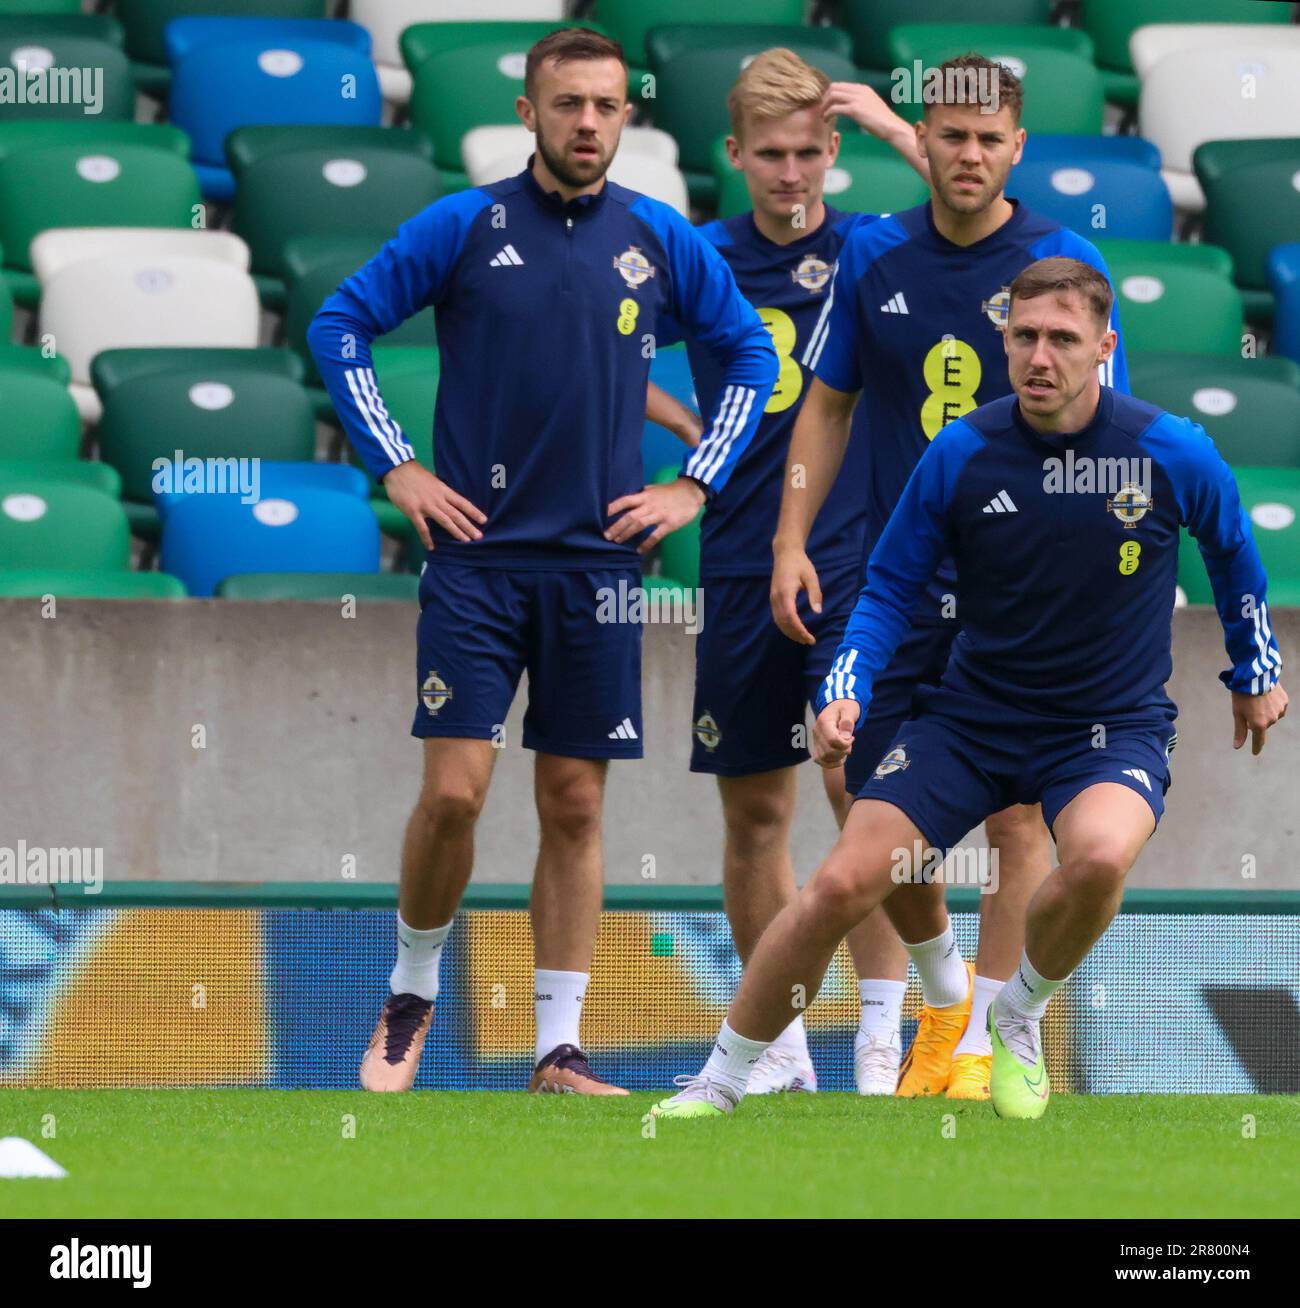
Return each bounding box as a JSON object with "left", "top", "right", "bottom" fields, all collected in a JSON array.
[{"left": 855, "top": 688, "right": 1177, "bottom": 852}]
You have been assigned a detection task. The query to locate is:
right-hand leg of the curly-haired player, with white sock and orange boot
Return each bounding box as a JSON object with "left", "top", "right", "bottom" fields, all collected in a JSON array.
[{"left": 947, "top": 804, "right": 1052, "bottom": 1099}]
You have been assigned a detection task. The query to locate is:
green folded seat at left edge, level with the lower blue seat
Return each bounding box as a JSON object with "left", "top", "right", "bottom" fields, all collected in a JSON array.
[{"left": 0, "top": 470, "right": 131, "bottom": 572}]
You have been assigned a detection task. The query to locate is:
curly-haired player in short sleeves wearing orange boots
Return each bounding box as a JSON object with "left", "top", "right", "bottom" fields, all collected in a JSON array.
[{"left": 772, "top": 55, "right": 1127, "bottom": 1099}]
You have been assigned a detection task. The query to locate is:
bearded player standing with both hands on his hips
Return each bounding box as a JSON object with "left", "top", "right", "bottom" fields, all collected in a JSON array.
[{"left": 309, "top": 29, "right": 777, "bottom": 1095}]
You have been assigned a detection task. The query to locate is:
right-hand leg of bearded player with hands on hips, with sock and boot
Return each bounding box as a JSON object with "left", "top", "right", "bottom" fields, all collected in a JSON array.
[{"left": 528, "top": 753, "right": 626, "bottom": 1095}]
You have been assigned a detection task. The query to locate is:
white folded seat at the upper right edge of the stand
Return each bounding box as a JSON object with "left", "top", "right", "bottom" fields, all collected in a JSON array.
[{"left": 1138, "top": 47, "right": 1300, "bottom": 212}]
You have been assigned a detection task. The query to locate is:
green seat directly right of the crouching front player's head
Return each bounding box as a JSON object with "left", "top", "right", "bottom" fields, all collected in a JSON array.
[{"left": 1106, "top": 254, "right": 1242, "bottom": 356}]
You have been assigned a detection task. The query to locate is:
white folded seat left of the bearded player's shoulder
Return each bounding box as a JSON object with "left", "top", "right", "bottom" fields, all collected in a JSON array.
[{"left": 41, "top": 252, "right": 260, "bottom": 422}]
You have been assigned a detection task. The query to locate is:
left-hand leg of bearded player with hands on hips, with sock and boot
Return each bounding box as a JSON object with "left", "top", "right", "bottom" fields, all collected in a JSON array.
[{"left": 361, "top": 736, "right": 496, "bottom": 1091}]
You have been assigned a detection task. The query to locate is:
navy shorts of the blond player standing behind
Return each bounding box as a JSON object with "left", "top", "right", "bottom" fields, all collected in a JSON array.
[{"left": 691, "top": 560, "right": 862, "bottom": 777}]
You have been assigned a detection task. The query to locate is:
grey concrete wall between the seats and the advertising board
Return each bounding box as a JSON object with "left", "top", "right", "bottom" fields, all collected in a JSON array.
[{"left": 0, "top": 599, "right": 1300, "bottom": 889}]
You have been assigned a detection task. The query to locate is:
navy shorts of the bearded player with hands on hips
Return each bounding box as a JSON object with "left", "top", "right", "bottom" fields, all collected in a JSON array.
[{"left": 411, "top": 564, "right": 642, "bottom": 759}]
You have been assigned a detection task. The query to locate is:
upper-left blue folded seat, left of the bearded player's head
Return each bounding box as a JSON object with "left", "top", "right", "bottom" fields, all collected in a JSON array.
[{"left": 170, "top": 37, "right": 383, "bottom": 200}]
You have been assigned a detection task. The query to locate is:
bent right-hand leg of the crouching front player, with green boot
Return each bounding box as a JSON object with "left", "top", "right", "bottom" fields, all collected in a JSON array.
[{"left": 989, "top": 781, "right": 1155, "bottom": 1117}]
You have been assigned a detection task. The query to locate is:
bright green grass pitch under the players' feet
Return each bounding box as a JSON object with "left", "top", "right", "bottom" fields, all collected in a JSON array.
[{"left": 0, "top": 1090, "right": 1300, "bottom": 1218}]
